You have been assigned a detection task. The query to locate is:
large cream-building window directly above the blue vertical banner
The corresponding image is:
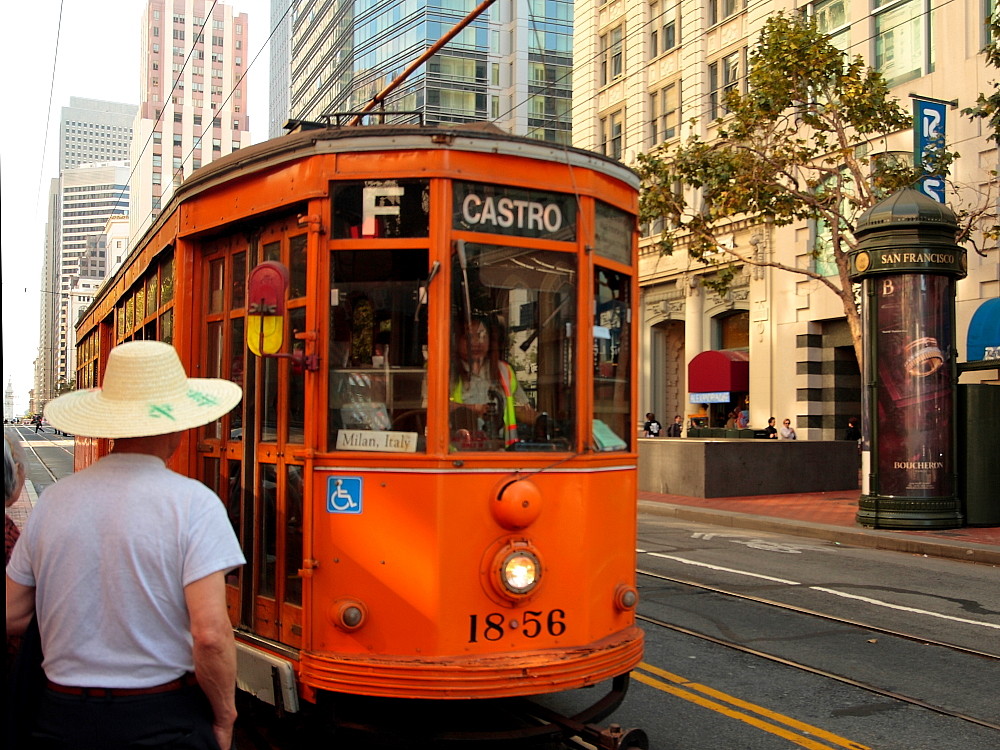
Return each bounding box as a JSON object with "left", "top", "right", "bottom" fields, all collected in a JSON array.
[{"left": 873, "top": 0, "right": 934, "bottom": 86}]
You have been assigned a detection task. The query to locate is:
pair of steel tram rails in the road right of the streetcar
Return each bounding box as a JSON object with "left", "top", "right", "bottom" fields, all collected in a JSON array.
[{"left": 636, "top": 568, "right": 1000, "bottom": 731}]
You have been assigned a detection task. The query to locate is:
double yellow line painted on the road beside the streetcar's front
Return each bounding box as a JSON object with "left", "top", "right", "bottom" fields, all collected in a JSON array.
[{"left": 632, "top": 662, "right": 871, "bottom": 750}]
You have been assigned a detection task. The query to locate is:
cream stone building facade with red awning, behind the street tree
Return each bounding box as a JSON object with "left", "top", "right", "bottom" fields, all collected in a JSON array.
[{"left": 573, "top": 0, "right": 1000, "bottom": 439}]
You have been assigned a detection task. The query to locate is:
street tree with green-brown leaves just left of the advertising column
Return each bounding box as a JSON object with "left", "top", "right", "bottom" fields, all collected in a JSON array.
[{"left": 637, "top": 13, "right": 985, "bottom": 362}]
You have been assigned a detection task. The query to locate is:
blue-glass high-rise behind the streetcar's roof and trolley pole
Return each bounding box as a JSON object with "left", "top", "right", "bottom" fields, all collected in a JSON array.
[{"left": 290, "top": 0, "right": 573, "bottom": 144}]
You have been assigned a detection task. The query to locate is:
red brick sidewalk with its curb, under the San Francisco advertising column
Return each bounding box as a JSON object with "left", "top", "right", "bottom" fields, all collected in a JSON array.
[{"left": 639, "top": 490, "right": 1000, "bottom": 565}]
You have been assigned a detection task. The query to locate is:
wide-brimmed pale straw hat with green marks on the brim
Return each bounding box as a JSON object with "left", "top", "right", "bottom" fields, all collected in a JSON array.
[{"left": 45, "top": 341, "right": 243, "bottom": 438}]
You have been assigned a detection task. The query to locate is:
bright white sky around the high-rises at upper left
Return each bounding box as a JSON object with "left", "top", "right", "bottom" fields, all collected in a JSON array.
[{"left": 0, "top": 0, "right": 270, "bottom": 416}]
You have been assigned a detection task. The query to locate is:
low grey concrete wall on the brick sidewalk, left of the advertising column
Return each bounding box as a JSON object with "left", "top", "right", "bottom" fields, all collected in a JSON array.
[{"left": 639, "top": 438, "right": 860, "bottom": 497}]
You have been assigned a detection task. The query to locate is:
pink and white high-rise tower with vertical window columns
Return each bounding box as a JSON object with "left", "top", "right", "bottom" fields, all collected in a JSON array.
[{"left": 129, "top": 0, "right": 250, "bottom": 238}]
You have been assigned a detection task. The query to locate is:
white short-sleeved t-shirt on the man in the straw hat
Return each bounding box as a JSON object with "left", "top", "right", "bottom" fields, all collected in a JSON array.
[{"left": 7, "top": 453, "right": 246, "bottom": 688}]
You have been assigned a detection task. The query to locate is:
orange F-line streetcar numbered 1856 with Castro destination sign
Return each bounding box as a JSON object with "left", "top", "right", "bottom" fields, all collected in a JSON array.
[{"left": 77, "top": 123, "right": 643, "bottom": 747}]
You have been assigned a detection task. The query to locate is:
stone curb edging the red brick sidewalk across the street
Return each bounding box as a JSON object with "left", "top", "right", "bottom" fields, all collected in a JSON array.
[{"left": 639, "top": 500, "right": 1000, "bottom": 566}]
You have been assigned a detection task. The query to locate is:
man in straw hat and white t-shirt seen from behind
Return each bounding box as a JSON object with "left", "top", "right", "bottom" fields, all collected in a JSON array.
[{"left": 7, "top": 341, "right": 246, "bottom": 750}]
